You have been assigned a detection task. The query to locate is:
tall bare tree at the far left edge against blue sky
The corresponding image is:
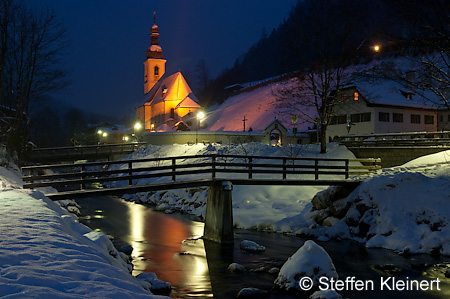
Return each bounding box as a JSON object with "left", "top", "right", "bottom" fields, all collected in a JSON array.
[{"left": 0, "top": 0, "right": 66, "bottom": 158}]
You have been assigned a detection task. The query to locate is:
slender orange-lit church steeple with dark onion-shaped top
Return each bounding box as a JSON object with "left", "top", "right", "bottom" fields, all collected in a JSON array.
[{"left": 144, "top": 12, "right": 166, "bottom": 94}]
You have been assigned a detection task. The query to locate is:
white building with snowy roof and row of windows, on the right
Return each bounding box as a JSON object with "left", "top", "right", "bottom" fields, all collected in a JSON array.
[{"left": 327, "top": 79, "right": 444, "bottom": 140}]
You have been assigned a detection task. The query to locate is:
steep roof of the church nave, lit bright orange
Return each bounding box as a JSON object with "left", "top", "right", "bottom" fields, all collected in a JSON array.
[{"left": 145, "top": 72, "right": 200, "bottom": 107}]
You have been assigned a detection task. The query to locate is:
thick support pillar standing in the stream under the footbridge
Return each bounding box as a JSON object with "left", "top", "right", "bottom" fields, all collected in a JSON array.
[{"left": 203, "top": 181, "right": 234, "bottom": 244}]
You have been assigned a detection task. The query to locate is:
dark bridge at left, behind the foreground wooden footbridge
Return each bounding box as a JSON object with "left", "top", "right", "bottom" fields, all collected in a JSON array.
[{"left": 25, "top": 142, "right": 146, "bottom": 163}]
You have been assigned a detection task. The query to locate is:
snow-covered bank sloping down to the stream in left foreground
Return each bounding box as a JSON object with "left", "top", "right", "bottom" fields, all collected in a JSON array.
[{"left": 0, "top": 167, "right": 166, "bottom": 298}]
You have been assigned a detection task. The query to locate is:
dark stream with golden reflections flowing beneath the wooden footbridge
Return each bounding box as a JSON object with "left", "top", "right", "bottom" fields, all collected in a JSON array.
[{"left": 77, "top": 196, "right": 450, "bottom": 299}]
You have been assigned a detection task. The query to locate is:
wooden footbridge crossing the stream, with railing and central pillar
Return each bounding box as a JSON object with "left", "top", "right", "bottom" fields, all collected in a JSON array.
[{"left": 22, "top": 155, "right": 381, "bottom": 244}]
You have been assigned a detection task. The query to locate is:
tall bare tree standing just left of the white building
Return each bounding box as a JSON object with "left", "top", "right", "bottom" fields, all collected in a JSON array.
[{"left": 275, "top": 0, "right": 370, "bottom": 153}]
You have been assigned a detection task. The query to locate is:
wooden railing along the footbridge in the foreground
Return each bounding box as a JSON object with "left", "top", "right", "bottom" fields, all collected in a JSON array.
[{"left": 22, "top": 154, "right": 381, "bottom": 189}]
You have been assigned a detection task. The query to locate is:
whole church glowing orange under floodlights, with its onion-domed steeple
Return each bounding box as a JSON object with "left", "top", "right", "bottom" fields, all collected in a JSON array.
[{"left": 136, "top": 18, "right": 201, "bottom": 131}]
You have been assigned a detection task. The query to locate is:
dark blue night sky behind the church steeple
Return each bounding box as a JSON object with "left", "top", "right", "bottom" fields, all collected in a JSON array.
[{"left": 26, "top": 0, "right": 295, "bottom": 116}]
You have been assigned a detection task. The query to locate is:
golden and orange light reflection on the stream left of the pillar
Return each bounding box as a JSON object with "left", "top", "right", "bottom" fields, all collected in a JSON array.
[{"left": 127, "top": 203, "right": 212, "bottom": 298}]
